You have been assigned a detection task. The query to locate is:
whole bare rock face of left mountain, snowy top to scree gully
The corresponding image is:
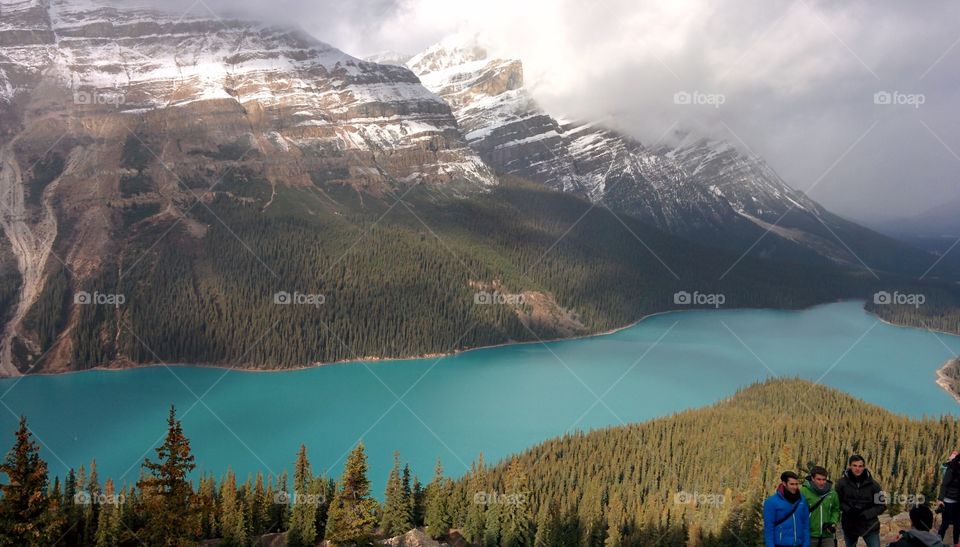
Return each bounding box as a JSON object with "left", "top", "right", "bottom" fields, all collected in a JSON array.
[{"left": 0, "top": 0, "right": 496, "bottom": 375}]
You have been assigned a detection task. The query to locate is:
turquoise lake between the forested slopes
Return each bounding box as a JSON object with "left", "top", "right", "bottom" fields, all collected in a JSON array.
[{"left": 0, "top": 302, "right": 960, "bottom": 497}]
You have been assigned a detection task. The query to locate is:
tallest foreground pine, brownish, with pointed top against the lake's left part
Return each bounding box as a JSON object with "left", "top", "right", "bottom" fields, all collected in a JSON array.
[{"left": 137, "top": 405, "right": 200, "bottom": 546}]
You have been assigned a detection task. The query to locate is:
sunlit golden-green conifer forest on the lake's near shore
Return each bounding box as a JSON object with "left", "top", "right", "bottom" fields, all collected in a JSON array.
[{"left": 0, "top": 380, "right": 960, "bottom": 547}]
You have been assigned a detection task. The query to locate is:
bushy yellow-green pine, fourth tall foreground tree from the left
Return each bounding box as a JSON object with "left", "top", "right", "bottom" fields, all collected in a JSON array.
[{"left": 327, "top": 442, "right": 377, "bottom": 545}]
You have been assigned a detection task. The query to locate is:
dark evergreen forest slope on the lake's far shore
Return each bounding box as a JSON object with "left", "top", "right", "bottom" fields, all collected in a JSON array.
[{"left": 35, "top": 178, "right": 870, "bottom": 370}]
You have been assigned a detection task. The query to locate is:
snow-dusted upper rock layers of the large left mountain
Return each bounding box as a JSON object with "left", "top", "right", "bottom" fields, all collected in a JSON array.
[{"left": 0, "top": 0, "right": 492, "bottom": 184}]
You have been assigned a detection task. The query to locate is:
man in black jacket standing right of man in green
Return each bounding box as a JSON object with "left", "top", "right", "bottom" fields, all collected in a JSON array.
[{"left": 834, "top": 454, "right": 887, "bottom": 547}]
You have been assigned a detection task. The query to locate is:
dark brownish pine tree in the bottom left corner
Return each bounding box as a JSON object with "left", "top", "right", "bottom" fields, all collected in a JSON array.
[{"left": 0, "top": 416, "right": 62, "bottom": 546}]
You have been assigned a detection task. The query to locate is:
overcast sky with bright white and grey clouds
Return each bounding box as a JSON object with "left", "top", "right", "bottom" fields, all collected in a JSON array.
[{"left": 174, "top": 0, "right": 960, "bottom": 224}]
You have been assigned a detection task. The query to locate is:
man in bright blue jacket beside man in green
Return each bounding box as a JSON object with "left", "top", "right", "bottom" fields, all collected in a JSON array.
[{"left": 763, "top": 471, "right": 810, "bottom": 547}]
